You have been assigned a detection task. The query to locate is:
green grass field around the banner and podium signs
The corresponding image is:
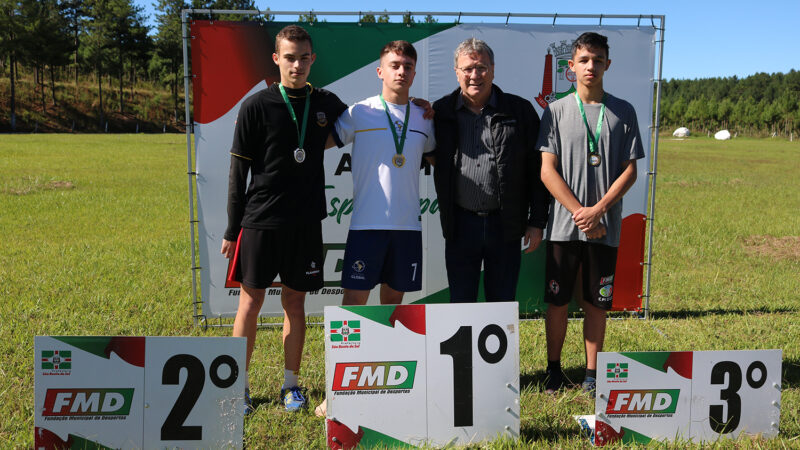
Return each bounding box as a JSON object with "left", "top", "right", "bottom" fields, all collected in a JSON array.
[{"left": 0, "top": 135, "right": 800, "bottom": 448}]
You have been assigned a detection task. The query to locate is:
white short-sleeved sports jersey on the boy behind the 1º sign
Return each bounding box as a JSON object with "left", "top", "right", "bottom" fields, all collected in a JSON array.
[{"left": 336, "top": 95, "right": 436, "bottom": 230}]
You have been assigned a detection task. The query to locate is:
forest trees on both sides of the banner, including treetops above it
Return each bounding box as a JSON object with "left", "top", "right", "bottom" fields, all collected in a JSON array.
[{"left": 0, "top": 0, "right": 800, "bottom": 135}]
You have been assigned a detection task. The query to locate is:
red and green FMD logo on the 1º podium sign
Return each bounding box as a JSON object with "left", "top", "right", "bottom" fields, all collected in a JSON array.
[{"left": 333, "top": 361, "right": 417, "bottom": 391}]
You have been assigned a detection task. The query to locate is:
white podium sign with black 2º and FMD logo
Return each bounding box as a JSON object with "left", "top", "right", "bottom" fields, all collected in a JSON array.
[{"left": 34, "top": 336, "right": 245, "bottom": 449}]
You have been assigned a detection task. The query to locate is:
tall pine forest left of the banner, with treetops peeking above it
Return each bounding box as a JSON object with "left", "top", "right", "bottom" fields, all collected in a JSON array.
[{"left": 0, "top": 0, "right": 436, "bottom": 131}]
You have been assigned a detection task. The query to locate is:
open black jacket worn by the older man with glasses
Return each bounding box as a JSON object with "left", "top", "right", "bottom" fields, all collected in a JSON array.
[{"left": 433, "top": 85, "right": 550, "bottom": 241}]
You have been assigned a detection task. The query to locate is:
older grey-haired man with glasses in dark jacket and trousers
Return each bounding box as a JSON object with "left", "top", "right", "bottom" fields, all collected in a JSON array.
[{"left": 433, "top": 38, "right": 549, "bottom": 302}]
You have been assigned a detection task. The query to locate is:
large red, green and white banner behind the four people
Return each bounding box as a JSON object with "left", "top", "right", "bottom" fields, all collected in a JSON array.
[{"left": 190, "top": 21, "right": 656, "bottom": 318}]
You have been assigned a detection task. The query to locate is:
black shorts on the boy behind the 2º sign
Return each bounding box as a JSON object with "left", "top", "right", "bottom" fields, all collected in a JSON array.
[{"left": 235, "top": 222, "right": 323, "bottom": 292}]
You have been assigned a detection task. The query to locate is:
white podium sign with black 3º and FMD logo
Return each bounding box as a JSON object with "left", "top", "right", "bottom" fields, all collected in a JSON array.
[{"left": 595, "top": 350, "right": 781, "bottom": 445}]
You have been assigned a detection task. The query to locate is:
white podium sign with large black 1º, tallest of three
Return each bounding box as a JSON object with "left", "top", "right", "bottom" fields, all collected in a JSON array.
[{"left": 325, "top": 302, "right": 519, "bottom": 448}]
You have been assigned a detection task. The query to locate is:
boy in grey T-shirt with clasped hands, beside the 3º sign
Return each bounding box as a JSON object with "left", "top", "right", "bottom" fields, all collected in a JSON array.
[{"left": 536, "top": 32, "right": 644, "bottom": 396}]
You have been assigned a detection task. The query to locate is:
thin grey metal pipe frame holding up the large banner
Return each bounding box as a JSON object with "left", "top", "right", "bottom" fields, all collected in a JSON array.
[{"left": 181, "top": 9, "right": 665, "bottom": 327}]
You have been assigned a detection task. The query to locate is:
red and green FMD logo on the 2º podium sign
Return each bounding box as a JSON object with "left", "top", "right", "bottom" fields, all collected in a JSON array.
[{"left": 42, "top": 388, "right": 133, "bottom": 416}]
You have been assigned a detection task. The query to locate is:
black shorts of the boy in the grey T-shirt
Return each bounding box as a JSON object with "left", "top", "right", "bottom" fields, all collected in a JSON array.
[{"left": 544, "top": 241, "right": 617, "bottom": 310}]
